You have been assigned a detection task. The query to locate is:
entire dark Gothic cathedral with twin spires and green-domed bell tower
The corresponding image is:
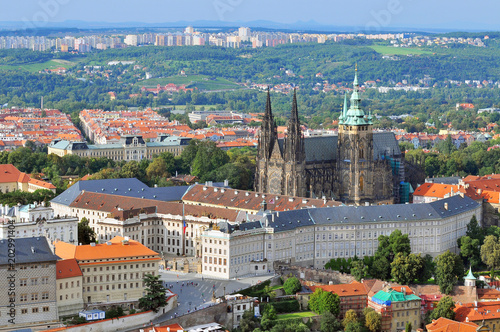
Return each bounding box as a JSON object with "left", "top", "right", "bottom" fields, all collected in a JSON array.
[{"left": 255, "top": 70, "right": 405, "bottom": 205}]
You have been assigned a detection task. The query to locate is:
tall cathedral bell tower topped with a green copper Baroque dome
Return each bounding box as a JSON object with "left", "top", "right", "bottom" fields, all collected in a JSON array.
[{"left": 337, "top": 66, "right": 375, "bottom": 205}]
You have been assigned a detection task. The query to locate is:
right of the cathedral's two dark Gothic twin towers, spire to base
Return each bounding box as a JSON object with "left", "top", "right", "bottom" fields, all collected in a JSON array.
[{"left": 284, "top": 90, "right": 306, "bottom": 197}]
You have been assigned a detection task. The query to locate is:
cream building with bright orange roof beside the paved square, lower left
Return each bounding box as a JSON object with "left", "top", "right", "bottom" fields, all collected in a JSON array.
[{"left": 55, "top": 236, "right": 160, "bottom": 309}]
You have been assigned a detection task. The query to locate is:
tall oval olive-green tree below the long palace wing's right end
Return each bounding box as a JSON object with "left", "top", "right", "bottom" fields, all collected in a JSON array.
[{"left": 436, "top": 250, "right": 464, "bottom": 294}]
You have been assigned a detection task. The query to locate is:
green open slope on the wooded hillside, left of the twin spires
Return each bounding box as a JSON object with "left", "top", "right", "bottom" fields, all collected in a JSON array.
[{"left": 136, "top": 75, "right": 241, "bottom": 90}]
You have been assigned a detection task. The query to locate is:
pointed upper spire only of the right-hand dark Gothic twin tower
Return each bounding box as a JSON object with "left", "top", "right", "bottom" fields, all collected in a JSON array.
[{"left": 285, "top": 89, "right": 305, "bottom": 162}]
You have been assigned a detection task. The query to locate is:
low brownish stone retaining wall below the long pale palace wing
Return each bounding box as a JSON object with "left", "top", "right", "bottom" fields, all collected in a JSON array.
[{"left": 274, "top": 262, "right": 355, "bottom": 284}]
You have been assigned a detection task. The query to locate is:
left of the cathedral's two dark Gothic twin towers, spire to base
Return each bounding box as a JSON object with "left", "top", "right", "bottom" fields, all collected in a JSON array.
[{"left": 255, "top": 89, "right": 278, "bottom": 192}]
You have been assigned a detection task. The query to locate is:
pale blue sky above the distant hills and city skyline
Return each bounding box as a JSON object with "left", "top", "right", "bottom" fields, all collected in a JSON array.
[{"left": 0, "top": 0, "right": 500, "bottom": 30}]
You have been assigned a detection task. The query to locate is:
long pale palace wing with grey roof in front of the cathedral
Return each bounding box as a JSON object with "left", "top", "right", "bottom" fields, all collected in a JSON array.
[{"left": 202, "top": 196, "right": 482, "bottom": 278}]
